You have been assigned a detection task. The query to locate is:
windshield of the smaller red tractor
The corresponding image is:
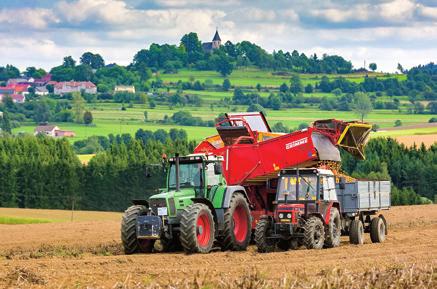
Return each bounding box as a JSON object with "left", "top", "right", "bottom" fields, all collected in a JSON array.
[{"left": 278, "top": 175, "right": 317, "bottom": 201}]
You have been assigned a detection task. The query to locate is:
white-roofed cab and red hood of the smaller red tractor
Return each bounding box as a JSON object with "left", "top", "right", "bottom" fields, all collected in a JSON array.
[{"left": 275, "top": 168, "right": 337, "bottom": 224}]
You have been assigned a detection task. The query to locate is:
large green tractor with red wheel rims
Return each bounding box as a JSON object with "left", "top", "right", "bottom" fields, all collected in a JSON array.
[{"left": 121, "top": 154, "right": 252, "bottom": 254}]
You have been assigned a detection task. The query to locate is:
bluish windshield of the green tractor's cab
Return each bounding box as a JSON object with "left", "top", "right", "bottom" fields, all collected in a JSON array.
[{"left": 168, "top": 163, "right": 203, "bottom": 189}]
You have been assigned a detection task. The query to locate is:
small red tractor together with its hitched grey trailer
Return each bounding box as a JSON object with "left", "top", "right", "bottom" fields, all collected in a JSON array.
[{"left": 255, "top": 168, "right": 390, "bottom": 252}]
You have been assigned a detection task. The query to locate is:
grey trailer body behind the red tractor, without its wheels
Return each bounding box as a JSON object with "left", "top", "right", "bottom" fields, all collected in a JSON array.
[{"left": 336, "top": 181, "right": 391, "bottom": 214}]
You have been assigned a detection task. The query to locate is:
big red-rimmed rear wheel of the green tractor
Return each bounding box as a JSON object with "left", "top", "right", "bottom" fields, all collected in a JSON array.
[{"left": 222, "top": 193, "right": 252, "bottom": 251}]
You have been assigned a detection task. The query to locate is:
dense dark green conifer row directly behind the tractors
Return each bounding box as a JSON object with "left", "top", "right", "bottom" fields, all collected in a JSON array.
[{"left": 0, "top": 131, "right": 430, "bottom": 211}]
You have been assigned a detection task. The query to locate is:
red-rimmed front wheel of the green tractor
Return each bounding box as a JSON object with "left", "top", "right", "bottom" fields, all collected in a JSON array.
[{"left": 179, "top": 203, "right": 215, "bottom": 254}]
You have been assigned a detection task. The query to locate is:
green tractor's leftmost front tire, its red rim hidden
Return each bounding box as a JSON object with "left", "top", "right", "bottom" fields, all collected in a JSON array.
[{"left": 121, "top": 205, "right": 155, "bottom": 254}]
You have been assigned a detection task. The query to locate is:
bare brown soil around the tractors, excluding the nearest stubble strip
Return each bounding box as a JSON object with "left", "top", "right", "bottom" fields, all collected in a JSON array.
[{"left": 0, "top": 205, "right": 437, "bottom": 288}]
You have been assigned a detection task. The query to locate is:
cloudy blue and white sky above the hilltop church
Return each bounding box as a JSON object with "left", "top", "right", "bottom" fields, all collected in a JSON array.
[{"left": 0, "top": 0, "right": 437, "bottom": 72}]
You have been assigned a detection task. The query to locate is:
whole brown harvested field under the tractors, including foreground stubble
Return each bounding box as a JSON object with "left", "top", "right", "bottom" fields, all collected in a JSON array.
[{"left": 0, "top": 205, "right": 437, "bottom": 288}]
